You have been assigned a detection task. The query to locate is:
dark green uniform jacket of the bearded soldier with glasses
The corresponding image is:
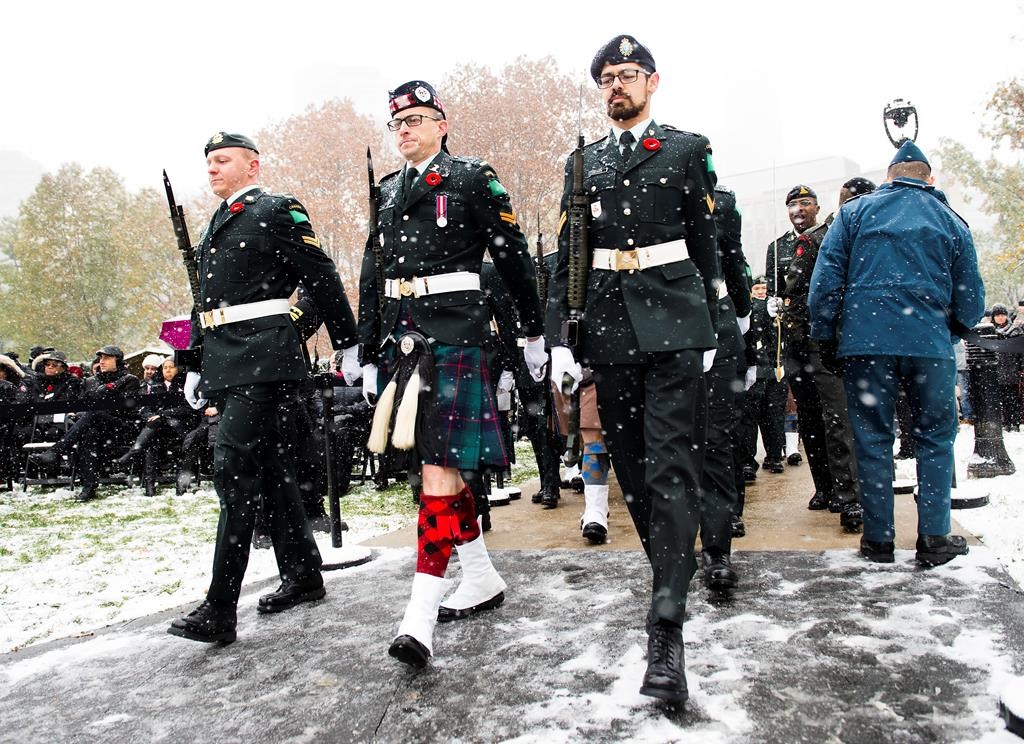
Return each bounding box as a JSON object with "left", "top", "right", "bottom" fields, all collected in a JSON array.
[{"left": 547, "top": 123, "right": 719, "bottom": 365}]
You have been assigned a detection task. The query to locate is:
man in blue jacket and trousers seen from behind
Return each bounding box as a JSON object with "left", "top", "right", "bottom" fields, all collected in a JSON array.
[{"left": 808, "top": 140, "right": 985, "bottom": 566}]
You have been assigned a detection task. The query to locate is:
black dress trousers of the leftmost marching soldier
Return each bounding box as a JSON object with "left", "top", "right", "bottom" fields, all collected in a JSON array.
[{"left": 207, "top": 383, "right": 322, "bottom": 605}]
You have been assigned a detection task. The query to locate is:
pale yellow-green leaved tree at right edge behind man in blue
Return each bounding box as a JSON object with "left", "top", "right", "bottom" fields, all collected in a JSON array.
[{"left": 939, "top": 80, "right": 1024, "bottom": 302}]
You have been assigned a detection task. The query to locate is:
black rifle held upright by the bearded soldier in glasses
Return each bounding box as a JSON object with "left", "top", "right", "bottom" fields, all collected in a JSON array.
[{"left": 561, "top": 122, "right": 590, "bottom": 468}]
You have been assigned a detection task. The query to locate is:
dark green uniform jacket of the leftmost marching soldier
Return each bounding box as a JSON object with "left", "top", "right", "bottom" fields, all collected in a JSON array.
[{"left": 193, "top": 188, "right": 356, "bottom": 393}]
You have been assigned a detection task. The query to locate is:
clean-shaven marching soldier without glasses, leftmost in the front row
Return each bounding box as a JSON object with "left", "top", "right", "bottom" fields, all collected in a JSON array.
[{"left": 168, "top": 132, "right": 359, "bottom": 644}]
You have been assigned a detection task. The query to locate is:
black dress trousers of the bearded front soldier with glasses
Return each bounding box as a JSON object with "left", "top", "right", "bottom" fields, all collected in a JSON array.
[{"left": 591, "top": 349, "right": 707, "bottom": 625}]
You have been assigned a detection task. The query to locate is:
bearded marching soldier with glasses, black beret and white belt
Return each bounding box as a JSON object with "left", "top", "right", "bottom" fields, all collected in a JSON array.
[{"left": 547, "top": 36, "right": 719, "bottom": 703}]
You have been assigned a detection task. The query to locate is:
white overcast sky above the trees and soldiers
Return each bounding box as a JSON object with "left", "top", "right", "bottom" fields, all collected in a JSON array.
[{"left": 0, "top": 0, "right": 1024, "bottom": 204}]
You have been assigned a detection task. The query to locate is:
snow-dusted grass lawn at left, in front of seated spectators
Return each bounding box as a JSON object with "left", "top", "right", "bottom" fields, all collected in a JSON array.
[{"left": 0, "top": 443, "right": 537, "bottom": 653}]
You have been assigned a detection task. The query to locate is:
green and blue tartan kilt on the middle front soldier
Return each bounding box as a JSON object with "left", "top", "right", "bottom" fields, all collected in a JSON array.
[{"left": 389, "top": 341, "right": 508, "bottom": 471}]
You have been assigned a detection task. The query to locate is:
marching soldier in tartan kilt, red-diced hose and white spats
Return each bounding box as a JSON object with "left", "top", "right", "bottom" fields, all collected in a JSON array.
[{"left": 359, "top": 80, "right": 548, "bottom": 667}]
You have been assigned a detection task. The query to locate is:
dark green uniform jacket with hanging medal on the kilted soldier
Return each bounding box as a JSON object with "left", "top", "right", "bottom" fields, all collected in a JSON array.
[{"left": 359, "top": 150, "right": 544, "bottom": 363}]
